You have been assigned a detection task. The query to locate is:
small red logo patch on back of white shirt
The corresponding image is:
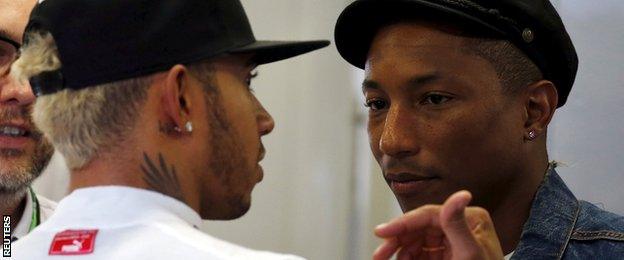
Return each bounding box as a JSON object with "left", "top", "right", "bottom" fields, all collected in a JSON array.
[{"left": 48, "top": 229, "right": 98, "bottom": 255}]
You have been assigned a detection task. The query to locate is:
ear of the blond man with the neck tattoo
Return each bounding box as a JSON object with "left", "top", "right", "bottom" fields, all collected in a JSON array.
[{"left": 162, "top": 65, "right": 190, "bottom": 129}]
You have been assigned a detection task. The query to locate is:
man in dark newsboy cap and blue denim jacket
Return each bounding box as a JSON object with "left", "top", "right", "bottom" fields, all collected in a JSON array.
[{"left": 335, "top": 0, "right": 624, "bottom": 259}]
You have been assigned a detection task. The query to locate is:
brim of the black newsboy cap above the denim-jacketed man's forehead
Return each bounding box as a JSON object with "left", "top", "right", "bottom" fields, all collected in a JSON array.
[{"left": 334, "top": 0, "right": 503, "bottom": 69}]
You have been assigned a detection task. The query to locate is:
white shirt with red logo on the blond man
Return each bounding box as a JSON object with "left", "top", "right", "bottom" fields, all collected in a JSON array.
[{"left": 12, "top": 186, "right": 301, "bottom": 260}]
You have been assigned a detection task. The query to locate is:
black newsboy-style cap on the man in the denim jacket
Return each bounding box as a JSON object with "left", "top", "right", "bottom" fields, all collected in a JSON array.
[{"left": 335, "top": 0, "right": 578, "bottom": 107}]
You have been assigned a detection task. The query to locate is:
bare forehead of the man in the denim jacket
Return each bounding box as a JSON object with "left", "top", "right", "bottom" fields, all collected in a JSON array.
[{"left": 365, "top": 23, "right": 498, "bottom": 91}]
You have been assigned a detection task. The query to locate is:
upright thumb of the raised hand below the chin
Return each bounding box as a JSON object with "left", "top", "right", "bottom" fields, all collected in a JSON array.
[{"left": 440, "top": 191, "right": 478, "bottom": 254}]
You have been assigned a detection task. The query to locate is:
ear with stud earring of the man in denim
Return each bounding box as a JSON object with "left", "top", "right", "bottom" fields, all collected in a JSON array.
[{"left": 524, "top": 80, "right": 559, "bottom": 139}]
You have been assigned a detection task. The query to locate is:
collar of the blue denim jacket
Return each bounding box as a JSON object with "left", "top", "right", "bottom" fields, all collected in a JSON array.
[{"left": 512, "top": 167, "right": 580, "bottom": 259}]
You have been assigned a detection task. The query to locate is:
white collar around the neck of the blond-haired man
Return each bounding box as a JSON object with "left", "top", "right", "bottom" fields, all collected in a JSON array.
[{"left": 41, "top": 186, "right": 202, "bottom": 229}]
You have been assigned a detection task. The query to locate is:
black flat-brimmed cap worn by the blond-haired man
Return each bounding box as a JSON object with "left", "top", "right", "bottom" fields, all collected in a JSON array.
[{"left": 26, "top": 0, "right": 329, "bottom": 96}]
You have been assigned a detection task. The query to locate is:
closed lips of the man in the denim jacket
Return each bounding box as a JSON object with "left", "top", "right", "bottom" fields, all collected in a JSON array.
[{"left": 385, "top": 172, "right": 440, "bottom": 195}]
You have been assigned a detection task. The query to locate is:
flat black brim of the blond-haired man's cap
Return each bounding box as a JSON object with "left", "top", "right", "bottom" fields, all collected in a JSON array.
[{"left": 228, "top": 40, "right": 330, "bottom": 64}]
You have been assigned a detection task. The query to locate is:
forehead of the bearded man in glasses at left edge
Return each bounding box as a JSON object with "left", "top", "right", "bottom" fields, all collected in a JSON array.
[{"left": 0, "top": 0, "right": 37, "bottom": 42}]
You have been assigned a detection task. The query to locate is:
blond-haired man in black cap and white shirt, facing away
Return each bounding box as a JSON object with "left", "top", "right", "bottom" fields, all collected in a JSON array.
[{"left": 13, "top": 0, "right": 328, "bottom": 259}]
